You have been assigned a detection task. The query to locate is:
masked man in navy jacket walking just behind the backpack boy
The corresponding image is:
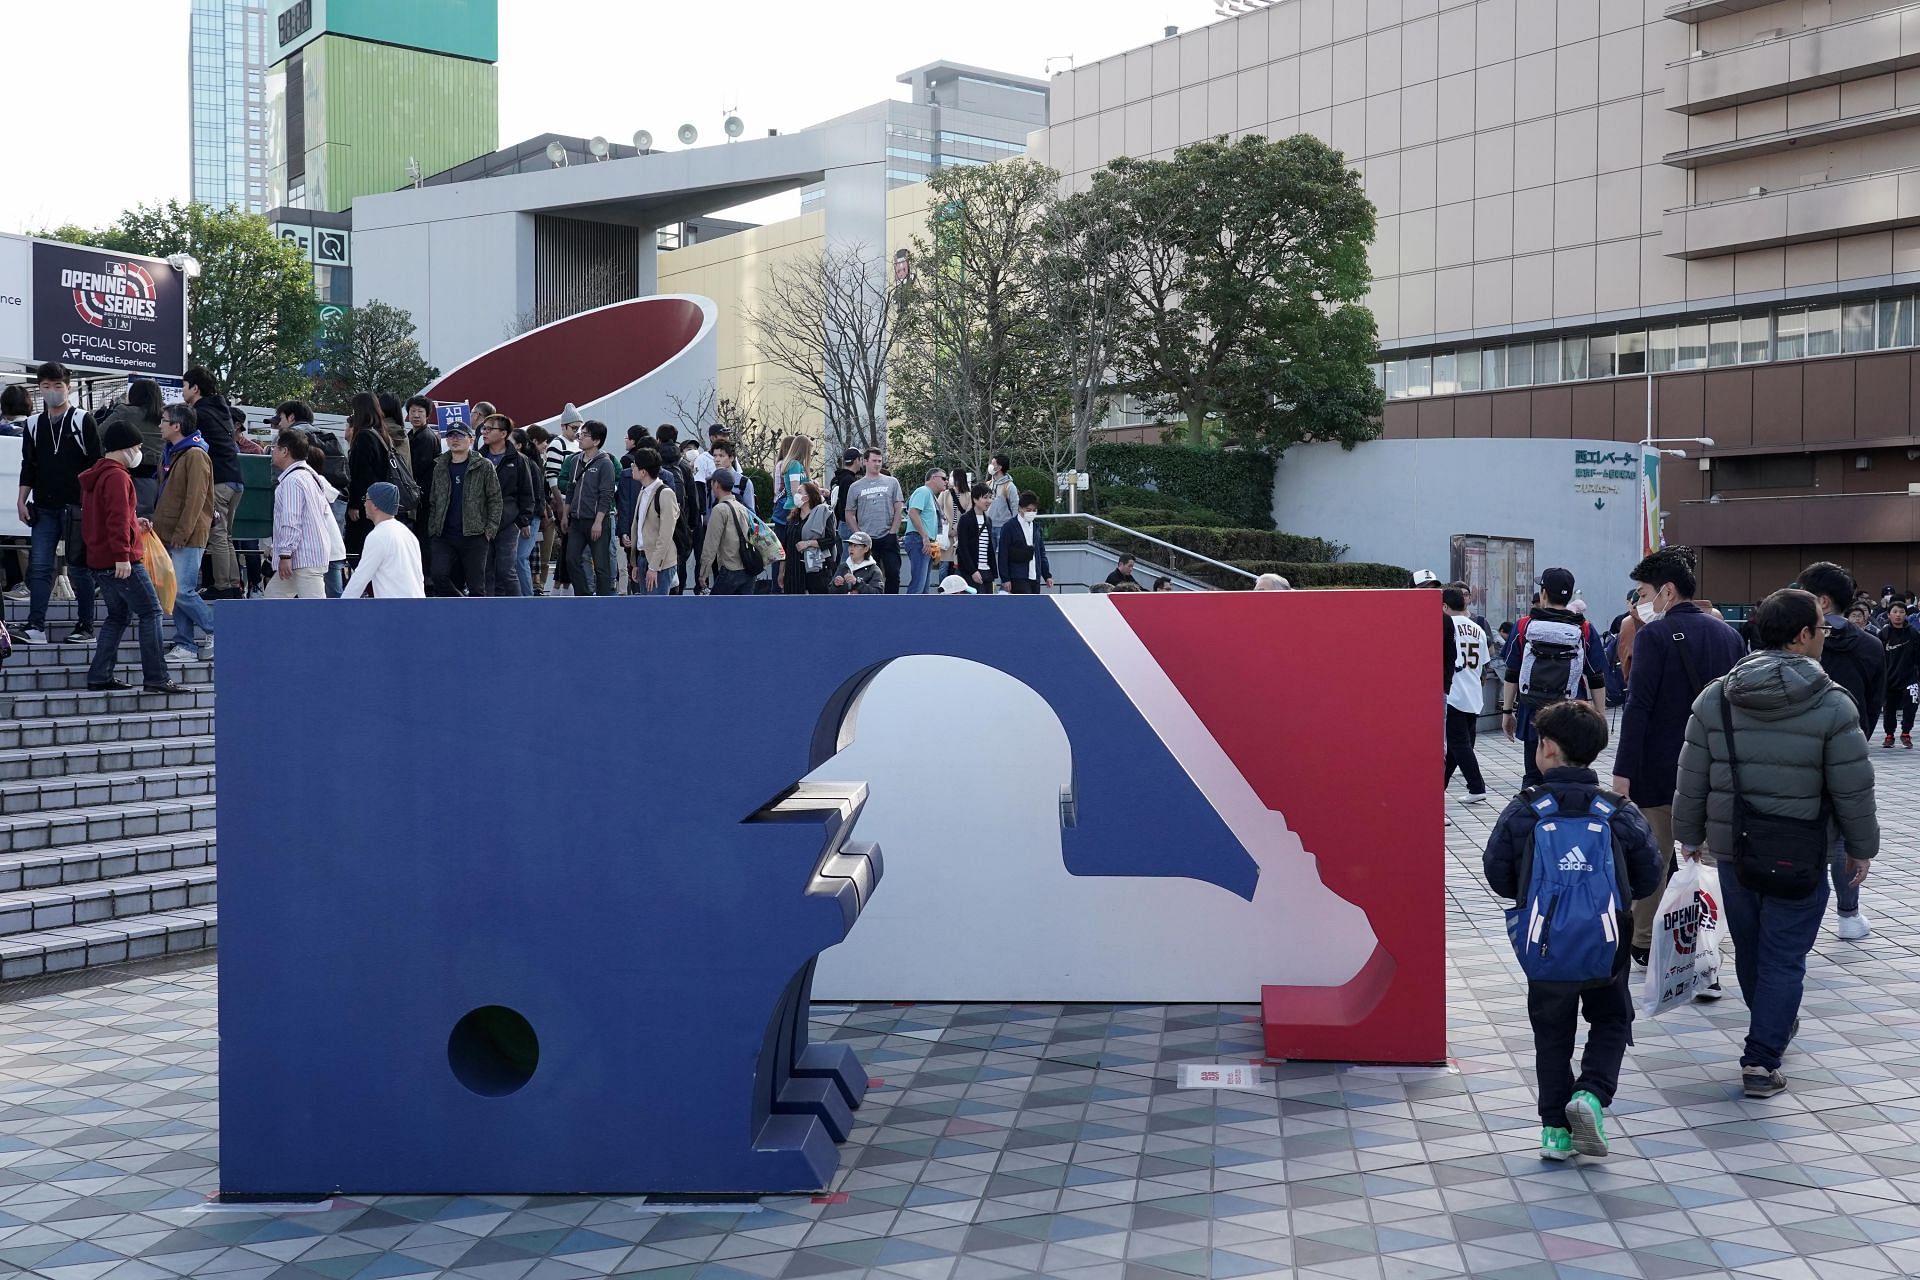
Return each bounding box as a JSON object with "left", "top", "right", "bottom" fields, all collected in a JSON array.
[{"left": 1613, "top": 547, "right": 1745, "bottom": 971}]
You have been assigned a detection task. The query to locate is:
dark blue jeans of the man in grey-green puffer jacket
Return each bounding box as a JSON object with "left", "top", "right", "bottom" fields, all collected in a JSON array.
[{"left": 1720, "top": 871, "right": 1828, "bottom": 1071}]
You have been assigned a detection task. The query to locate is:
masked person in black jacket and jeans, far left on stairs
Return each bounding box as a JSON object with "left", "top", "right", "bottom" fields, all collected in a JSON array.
[{"left": 15, "top": 361, "right": 100, "bottom": 645}]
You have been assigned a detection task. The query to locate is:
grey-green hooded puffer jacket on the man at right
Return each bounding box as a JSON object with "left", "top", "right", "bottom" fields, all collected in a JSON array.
[{"left": 1672, "top": 649, "right": 1880, "bottom": 858}]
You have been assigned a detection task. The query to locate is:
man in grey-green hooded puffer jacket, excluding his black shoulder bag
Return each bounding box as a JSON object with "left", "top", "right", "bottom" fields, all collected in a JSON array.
[{"left": 1674, "top": 589, "right": 1880, "bottom": 1098}]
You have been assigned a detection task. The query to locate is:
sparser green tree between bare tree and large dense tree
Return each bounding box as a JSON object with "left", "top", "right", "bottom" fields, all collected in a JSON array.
[{"left": 887, "top": 159, "right": 1066, "bottom": 470}]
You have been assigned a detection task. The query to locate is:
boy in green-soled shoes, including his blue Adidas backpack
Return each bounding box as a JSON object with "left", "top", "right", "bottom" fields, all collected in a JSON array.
[{"left": 1484, "top": 702, "right": 1661, "bottom": 1159}]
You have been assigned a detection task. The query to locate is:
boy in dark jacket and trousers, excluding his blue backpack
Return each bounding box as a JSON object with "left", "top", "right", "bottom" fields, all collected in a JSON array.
[{"left": 1484, "top": 702, "right": 1661, "bottom": 1159}]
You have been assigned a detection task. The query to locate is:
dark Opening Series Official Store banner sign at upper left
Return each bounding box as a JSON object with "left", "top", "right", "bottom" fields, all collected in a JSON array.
[{"left": 31, "top": 240, "right": 186, "bottom": 376}]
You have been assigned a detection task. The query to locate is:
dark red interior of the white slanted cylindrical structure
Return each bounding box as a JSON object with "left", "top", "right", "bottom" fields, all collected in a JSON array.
[{"left": 426, "top": 297, "right": 701, "bottom": 426}]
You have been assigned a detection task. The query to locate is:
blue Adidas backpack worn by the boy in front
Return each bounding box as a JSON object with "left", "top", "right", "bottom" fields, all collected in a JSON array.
[{"left": 1507, "top": 787, "right": 1622, "bottom": 984}]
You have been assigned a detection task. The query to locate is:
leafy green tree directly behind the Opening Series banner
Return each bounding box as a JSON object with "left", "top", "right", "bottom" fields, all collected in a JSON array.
[{"left": 42, "top": 200, "right": 315, "bottom": 405}]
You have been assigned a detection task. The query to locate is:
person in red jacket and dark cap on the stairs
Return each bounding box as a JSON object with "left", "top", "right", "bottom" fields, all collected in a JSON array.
[{"left": 81, "top": 418, "right": 186, "bottom": 693}]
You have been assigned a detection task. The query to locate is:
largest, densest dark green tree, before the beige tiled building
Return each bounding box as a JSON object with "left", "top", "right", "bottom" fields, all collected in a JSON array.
[{"left": 1089, "top": 134, "right": 1382, "bottom": 451}]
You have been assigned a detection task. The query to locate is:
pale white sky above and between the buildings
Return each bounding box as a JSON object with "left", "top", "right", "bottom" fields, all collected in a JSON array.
[{"left": 0, "top": 0, "right": 1215, "bottom": 232}]
